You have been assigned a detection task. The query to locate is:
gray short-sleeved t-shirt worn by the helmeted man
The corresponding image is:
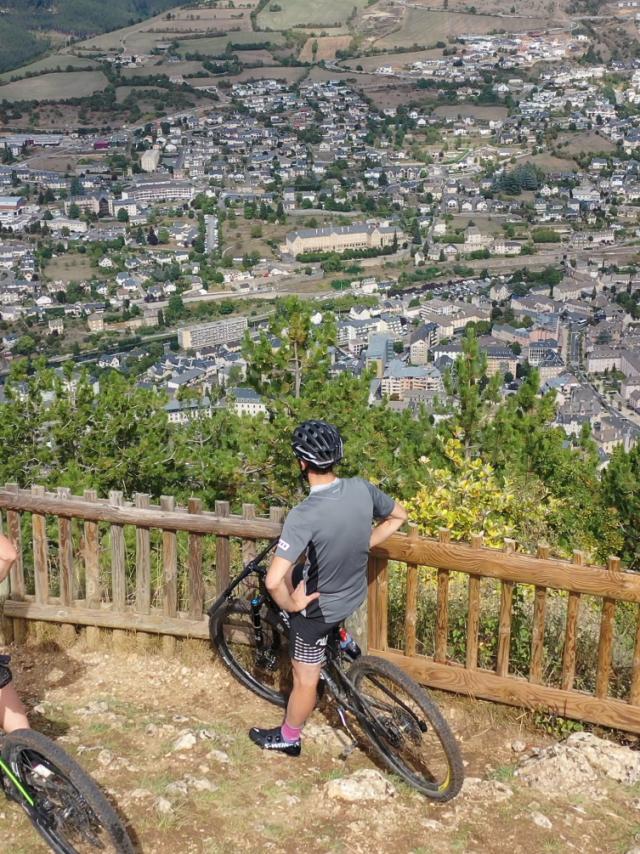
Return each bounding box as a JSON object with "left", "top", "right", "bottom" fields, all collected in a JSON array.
[{"left": 276, "top": 477, "right": 395, "bottom": 623}]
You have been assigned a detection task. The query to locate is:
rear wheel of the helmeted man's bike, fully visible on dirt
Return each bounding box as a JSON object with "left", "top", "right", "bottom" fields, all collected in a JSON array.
[{"left": 347, "top": 656, "right": 464, "bottom": 801}]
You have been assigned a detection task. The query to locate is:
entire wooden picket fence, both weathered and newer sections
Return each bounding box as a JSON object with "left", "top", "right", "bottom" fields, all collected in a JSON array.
[{"left": 0, "top": 484, "right": 640, "bottom": 733}]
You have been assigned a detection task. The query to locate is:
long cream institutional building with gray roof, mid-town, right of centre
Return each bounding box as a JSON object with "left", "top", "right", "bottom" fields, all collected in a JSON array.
[{"left": 280, "top": 222, "right": 404, "bottom": 257}]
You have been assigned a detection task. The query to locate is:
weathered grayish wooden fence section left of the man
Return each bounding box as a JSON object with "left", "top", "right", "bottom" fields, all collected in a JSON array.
[{"left": 0, "top": 484, "right": 284, "bottom": 651}]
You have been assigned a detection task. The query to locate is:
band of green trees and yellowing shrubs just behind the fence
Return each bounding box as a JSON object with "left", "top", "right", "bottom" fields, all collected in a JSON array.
[{"left": 0, "top": 299, "right": 640, "bottom": 569}]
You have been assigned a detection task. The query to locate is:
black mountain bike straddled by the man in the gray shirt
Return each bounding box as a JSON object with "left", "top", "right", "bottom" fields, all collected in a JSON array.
[{"left": 208, "top": 540, "right": 464, "bottom": 802}]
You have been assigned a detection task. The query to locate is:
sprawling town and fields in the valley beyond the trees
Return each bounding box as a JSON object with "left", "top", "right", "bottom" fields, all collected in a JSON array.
[{"left": 0, "top": 0, "right": 640, "bottom": 467}]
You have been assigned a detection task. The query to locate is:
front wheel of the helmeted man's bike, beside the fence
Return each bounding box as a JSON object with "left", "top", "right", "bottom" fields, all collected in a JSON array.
[{"left": 209, "top": 599, "right": 292, "bottom": 707}]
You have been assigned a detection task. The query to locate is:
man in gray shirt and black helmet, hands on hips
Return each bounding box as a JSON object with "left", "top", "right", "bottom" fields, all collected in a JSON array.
[{"left": 249, "top": 421, "right": 407, "bottom": 756}]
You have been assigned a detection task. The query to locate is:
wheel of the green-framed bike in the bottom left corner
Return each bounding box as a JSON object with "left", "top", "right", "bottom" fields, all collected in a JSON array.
[{"left": 2, "top": 729, "right": 135, "bottom": 854}]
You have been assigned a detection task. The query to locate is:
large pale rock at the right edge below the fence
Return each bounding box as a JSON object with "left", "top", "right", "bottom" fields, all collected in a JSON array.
[{"left": 516, "top": 732, "right": 640, "bottom": 795}]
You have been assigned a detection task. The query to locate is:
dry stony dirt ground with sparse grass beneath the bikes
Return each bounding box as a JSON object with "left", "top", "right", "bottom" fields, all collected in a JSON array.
[{"left": 0, "top": 640, "right": 640, "bottom": 854}]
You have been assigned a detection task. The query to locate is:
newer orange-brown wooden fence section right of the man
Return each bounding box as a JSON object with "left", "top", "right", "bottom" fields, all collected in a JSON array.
[{"left": 368, "top": 530, "right": 640, "bottom": 733}]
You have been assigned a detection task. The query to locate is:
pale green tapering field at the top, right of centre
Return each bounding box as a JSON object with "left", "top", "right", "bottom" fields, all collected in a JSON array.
[{"left": 375, "top": 8, "right": 549, "bottom": 48}]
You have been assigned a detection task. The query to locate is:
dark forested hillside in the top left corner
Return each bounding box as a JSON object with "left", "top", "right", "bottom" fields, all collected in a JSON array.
[{"left": 0, "top": 0, "right": 180, "bottom": 71}]
